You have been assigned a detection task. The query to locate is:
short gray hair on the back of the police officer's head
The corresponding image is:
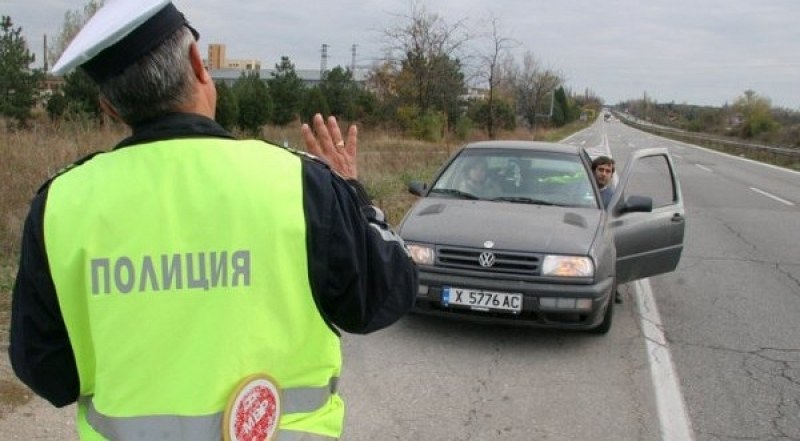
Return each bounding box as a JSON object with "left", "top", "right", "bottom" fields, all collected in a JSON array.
[{"left": 98, "top": 26, "right": 194, "bottom": 126}]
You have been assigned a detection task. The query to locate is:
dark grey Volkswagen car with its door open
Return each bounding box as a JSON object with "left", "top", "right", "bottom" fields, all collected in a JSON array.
[{"left": 398, "top": 141, "right": 685, "bottom": 333}]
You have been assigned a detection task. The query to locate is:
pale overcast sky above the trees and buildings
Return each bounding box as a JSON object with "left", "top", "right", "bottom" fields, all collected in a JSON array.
[{"left": 6, "top": 0, "right": 800, "bottom": 110}]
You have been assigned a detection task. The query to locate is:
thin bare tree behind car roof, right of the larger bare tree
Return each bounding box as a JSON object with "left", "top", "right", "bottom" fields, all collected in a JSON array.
[{"left": 478, "top": 15, "right": 519, "bottom": 139}]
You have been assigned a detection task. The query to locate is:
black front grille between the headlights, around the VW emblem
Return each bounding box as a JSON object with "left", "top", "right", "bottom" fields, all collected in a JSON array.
[{"left": 436, "top": 247, "right": 542, "bottom": 276}]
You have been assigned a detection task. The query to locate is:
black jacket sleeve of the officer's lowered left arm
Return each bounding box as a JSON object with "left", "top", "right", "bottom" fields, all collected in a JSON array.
[{"left": 8, "top": 189, "right": 80, "bottom": 407}]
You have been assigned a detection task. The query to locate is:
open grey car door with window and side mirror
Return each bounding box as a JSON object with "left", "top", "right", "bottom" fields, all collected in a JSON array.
[{"left": 608, "top": 148, "right": 686, "bottom": 284}]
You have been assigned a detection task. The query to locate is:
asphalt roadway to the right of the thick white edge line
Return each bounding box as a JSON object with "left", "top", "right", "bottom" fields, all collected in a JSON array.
[{"left": 580, "top": 118, "right": 800, "bottom": 441}]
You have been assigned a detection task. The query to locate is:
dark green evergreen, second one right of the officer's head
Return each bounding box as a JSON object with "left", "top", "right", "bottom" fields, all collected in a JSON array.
[{"left": 233, "top": 72, "right": 272, "bottom": 136}]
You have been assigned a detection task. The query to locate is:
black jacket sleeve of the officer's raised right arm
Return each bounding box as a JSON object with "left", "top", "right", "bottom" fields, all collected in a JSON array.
[{"left": 303, "top": 159, "right": 417, "bottom": 334}]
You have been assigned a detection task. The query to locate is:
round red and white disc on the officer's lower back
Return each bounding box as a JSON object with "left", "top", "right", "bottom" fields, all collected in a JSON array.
[{"left": 223, "top": 375, "right": 281, "bottom": 441}]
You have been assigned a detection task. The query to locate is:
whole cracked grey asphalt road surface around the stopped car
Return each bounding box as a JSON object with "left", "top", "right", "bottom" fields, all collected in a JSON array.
[{"left": 0, "top": 121, "right": 800, "bottom": 441}]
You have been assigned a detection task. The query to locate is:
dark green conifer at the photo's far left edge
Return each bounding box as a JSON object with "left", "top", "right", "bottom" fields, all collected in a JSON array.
[{"left": 0, "top": 15, "right": 43, "bottom": 126}]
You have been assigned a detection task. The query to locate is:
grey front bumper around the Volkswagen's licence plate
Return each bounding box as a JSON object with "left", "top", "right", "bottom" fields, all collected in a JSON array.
[{"left": 414, "top": 269, "right": 614, "bottom": 330}]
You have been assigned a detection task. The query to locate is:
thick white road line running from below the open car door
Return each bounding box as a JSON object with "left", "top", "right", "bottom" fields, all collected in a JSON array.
[{"left": 633, "top": 279, "right": 694, "bottom": 441}]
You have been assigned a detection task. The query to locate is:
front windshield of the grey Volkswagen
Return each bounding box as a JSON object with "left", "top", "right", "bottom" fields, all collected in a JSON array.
[{"left": 431, "top": 149, "right": 597, "bottom": 208}]
